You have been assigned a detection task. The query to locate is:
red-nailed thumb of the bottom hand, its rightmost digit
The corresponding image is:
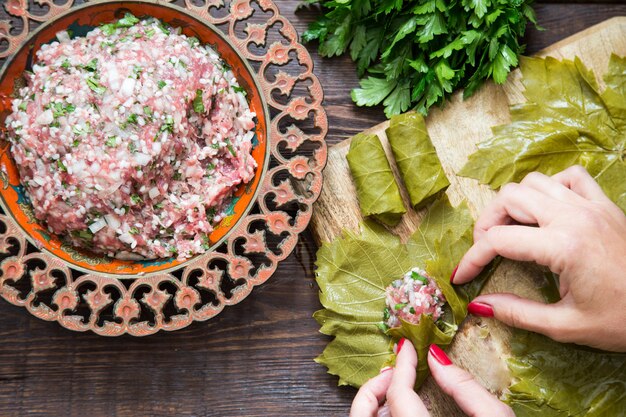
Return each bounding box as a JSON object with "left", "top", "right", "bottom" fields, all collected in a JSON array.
[{"left": 428, "top": 347, "right": 515, "bottom": 417}]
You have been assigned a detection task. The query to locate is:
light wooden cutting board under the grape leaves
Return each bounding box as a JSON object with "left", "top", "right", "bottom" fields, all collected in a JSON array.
[{"left": 311, "top": 17, "right": 626, "bottom": 416}]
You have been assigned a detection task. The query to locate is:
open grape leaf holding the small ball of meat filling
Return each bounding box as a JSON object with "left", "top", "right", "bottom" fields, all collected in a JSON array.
[{"left": 314, "top": 196, "right": 492, "bottom": 387}]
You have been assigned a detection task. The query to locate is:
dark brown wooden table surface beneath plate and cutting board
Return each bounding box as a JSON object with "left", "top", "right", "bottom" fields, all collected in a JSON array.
[{"left": 0, "top": 0, "right": 626, "bottom": 417}]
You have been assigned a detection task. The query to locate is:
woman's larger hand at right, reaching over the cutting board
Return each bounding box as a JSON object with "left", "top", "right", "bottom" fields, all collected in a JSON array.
[{"left": 451, "top": 166, "right": 626, "bottom": 351}]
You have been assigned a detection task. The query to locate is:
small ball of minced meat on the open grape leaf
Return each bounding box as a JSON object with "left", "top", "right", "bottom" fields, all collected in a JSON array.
[{"left": 384, "top": 268, "right": 446, "bottom": 327}]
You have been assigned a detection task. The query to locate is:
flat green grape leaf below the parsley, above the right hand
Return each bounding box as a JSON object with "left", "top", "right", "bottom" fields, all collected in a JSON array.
[{"left": 459, "top": 55, "right": 626, "bottom": 211}]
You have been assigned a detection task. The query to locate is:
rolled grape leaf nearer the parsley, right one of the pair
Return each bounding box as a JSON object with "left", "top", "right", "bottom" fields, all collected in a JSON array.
[{"left": 386, "top": 113, "right": 450, "bottom": 210}]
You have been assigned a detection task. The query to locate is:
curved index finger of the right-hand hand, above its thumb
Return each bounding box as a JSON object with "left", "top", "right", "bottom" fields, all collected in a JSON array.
[{"left": 453, "top": 225, "right": 555, "bottom": 284}]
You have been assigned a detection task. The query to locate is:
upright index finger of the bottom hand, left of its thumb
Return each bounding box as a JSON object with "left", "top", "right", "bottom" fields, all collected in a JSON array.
[{"left": 387, "top": 339, "right": 430, "bottom": 417}]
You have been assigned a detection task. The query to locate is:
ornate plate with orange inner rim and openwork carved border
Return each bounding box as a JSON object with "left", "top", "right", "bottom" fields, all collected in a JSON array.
[{"left": 0, "top": 0, "right": 327, "bottom": 336}]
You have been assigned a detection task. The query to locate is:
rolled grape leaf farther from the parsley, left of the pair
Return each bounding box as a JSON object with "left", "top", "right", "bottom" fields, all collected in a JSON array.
[{"left": 346, "top": 133, "right": 406, "bottom": 226}]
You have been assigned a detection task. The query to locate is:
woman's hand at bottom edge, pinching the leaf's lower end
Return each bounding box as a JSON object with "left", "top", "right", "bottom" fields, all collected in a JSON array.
[{"left": 350, "top": 339, "right": 515, "bottom": 417}]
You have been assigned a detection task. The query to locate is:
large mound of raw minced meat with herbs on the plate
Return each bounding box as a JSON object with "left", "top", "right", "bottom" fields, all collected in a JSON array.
[{"left": 6, "top": 15, "right": 256, "bottom": 259}]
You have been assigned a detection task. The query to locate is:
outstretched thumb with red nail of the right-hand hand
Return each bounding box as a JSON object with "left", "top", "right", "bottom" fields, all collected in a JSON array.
[{"left": 468, "top": 294, "right": 576, "bottom": 342}]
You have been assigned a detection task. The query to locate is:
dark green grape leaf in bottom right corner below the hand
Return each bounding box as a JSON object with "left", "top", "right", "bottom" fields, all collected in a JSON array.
[{"left": 505, "top": 330, "right": 626, "bottom": 417}]
